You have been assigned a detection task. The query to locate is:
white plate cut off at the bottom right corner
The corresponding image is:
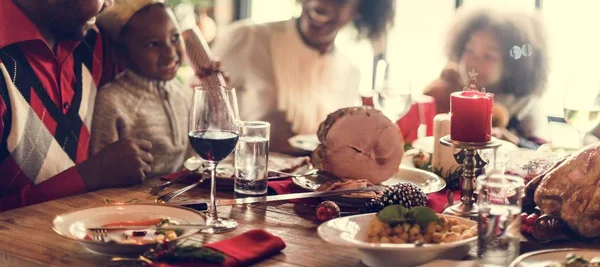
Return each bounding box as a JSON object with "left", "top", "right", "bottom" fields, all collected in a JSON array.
[{"left": 510, "top": 248, "right": 600, "bottom": 267}]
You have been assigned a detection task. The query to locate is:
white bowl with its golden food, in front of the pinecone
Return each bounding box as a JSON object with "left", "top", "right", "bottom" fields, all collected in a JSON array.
[{"left": 318, "top": 205, "right": 477, "bottom": 267}]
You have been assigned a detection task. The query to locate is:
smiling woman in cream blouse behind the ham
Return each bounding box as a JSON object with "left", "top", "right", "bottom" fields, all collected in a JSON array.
[{"left": 213, "top": 0, "right": 395, "bottom": 153}]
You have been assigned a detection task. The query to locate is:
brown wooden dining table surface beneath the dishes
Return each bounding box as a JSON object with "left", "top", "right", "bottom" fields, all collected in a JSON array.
[{"left": 0, "top": 175, "right": 600, "bottom": 267}]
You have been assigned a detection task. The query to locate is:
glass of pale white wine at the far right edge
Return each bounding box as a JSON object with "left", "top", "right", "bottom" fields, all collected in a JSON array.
[{"left": 563, "top": 81, "right": 600, "bottom": 148}]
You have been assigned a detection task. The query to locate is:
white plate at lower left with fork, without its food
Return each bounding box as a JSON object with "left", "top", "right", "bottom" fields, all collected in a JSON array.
[{"left": 52, "top": 204, "right": 206, "bottom": 255}]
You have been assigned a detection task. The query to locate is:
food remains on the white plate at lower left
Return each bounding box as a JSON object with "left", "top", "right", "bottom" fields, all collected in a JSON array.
[{"left": 85, "top": 218, "right": 183, "bottom": 245}]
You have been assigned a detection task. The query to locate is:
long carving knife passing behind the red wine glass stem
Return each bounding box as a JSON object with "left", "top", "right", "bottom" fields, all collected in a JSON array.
[{"left": 169, "top": 185, "right": 386, "bottom": 210}]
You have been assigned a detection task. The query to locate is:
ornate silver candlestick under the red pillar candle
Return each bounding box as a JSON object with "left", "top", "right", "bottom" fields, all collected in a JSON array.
[{"left": 440, "top": 135, "right": 502, "bottom": 218}]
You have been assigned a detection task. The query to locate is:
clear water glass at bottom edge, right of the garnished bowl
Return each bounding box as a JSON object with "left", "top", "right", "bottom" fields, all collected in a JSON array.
[{"left": 477, "top": 173, "right": 524, "bottom": 266}]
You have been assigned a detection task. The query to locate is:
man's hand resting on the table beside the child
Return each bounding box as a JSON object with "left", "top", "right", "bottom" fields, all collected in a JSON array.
[{"left": 77, "top": 139, "right": 154, "bottom": 190}]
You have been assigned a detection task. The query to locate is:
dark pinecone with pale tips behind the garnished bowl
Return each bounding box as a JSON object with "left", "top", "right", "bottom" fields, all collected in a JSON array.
[{"left": 361, "top": 183, "right": 427, "bottom": 213}]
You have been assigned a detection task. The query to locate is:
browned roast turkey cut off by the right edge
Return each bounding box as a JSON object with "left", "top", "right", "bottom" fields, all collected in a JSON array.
[{"left": 523, "top": 144, "right": 600, "bottom": 238}]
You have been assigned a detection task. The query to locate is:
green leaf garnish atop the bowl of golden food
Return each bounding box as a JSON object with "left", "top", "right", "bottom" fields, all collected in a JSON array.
[{"left": 377, "top": 205, "right": 441, "bottom": 229}]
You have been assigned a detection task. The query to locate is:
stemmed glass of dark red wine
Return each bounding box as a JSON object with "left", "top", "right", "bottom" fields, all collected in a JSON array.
[{"left": 188, "top": 86, "right": 239, "bottom": 233}]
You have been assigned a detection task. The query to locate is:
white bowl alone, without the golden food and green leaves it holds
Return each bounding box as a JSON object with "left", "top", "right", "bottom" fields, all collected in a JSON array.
[{"left": 317, "top": 213, "right": 477, "bottom": 267}]
